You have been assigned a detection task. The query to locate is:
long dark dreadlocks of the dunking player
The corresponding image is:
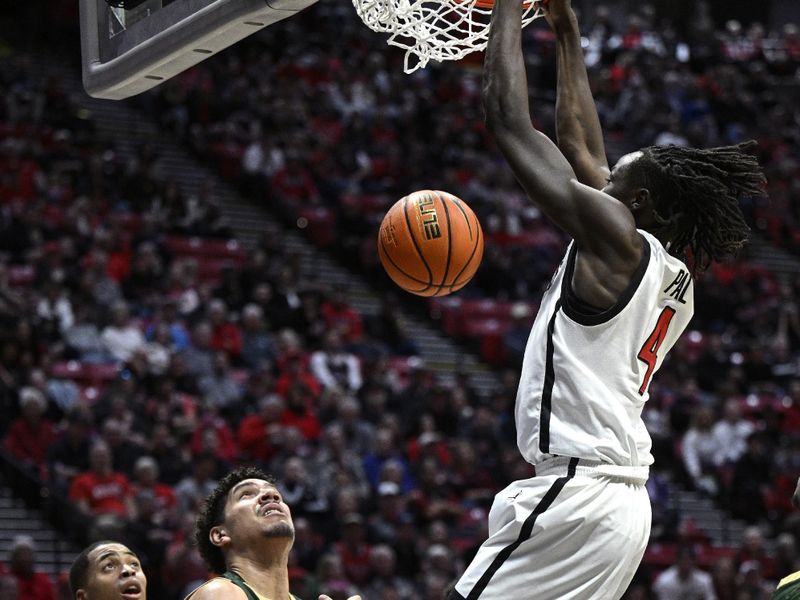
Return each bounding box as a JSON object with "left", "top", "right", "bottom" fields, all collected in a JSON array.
[{"left": 641, "top": 141, "right": 766, "bottom": 272}]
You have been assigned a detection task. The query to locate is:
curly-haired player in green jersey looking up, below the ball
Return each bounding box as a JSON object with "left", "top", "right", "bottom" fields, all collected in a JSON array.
[{"left": 186, "top": 467, "right": 361, "bottom": 600}]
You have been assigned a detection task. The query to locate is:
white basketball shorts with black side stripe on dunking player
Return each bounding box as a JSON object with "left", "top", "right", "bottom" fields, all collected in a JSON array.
[{"left": 450, "top": 458, "right": 651, "bottom": 600}]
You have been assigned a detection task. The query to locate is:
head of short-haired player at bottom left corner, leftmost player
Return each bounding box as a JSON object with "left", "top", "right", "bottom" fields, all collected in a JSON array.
[{"left": 69, "top": 540, "right": 147, "bottom": 600}]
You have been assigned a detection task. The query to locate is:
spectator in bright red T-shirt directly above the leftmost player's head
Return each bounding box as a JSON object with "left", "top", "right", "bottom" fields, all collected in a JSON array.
[{"left": 69, "top": 441, "right": 133, "bottom": 517}]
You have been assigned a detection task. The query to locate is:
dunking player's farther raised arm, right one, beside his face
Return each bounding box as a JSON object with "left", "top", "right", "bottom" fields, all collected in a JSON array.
[{"left": 544, "top": 0, "right": 609, "bottom": 190}]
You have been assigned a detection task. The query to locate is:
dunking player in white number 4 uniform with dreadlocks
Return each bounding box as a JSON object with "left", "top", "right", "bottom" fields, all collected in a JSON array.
[{"left": 450, "top": 0, "right": 765, "bottom": 600}]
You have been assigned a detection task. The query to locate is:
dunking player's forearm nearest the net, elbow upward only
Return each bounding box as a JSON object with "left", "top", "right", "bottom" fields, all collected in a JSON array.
[{"left": 483, "top": 0, "right": 530, "bottom": 131}]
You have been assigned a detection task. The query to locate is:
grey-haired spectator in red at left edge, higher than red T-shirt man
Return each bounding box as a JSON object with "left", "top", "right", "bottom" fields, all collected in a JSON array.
[{"left": 3, "top": 387, "right": 56, "bottom": 470}]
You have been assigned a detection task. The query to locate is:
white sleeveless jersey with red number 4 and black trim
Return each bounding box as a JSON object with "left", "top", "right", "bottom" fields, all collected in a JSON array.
[{"left": 516, "top": 230, "right": 694, "bottom": 466}]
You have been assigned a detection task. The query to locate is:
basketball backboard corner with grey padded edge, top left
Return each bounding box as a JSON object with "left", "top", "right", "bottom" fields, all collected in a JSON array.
[{"left": 80, "top": 0, "right": 317, "bottom": 100}]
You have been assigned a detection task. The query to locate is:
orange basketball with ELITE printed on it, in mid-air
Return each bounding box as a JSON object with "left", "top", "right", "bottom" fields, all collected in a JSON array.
[{"left": 378, "top": 190, "right": 483, "bottom": 296}]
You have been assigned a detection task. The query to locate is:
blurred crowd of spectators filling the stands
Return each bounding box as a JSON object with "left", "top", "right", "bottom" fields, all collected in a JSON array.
[{"left": 0, "top": 2, "right": 800, "bottom": 600}]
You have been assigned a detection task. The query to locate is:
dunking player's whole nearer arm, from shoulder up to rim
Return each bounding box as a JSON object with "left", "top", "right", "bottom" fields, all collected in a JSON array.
[{"left": 483, "top": 0, "right": 641, "bottom": 296}]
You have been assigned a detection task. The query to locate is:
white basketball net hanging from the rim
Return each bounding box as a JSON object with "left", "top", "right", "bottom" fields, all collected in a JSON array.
[{"left": 353, "top": 0, "right": 543, "bottom": 73}]
